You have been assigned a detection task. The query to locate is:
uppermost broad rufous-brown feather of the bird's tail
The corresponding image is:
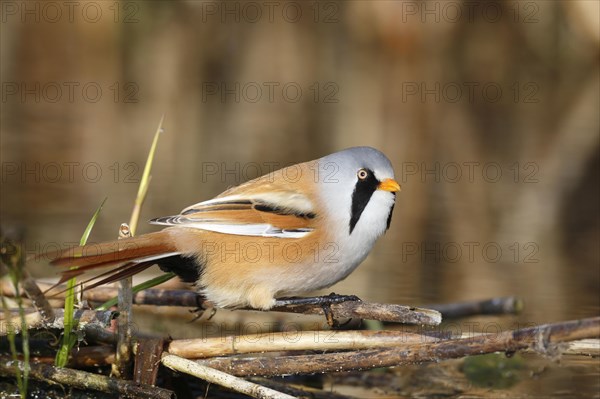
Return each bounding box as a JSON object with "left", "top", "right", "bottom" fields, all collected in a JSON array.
[{"left": 51, "top": 231, "right": 177, "bottom": 270}]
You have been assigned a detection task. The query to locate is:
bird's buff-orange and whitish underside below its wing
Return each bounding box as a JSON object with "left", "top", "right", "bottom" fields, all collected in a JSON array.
[{"left": 173, "top": 231, "right": 368, "bottom": 309}]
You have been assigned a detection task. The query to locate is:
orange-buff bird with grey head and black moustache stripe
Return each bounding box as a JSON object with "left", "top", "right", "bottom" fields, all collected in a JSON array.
[{"left": 51, "top": 147, "right": 400, "bottom": 310}]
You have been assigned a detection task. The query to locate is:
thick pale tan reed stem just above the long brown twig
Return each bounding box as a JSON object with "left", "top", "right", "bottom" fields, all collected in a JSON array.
[{"left": 168, "top": 330, "right": 440, "bottom": 359}]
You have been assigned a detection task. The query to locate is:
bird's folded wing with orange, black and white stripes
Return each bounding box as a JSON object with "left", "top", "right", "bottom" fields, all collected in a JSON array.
[{"left": 150, "top": 190, "right": 317, "bottom": 238}]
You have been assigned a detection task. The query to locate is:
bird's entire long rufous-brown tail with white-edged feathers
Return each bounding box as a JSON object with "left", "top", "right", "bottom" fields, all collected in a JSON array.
[{"left": 50, "top": 230, "right": 178, "bottom": 289}]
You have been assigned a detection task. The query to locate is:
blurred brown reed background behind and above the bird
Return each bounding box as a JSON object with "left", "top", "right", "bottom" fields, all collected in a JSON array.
[{"left": 0, "top": 1, "right": 600, "bottom": 328}]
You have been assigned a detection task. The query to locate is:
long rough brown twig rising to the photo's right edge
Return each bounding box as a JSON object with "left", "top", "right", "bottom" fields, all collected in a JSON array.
[{"left": 196, "top": 317, "right": 600, "bottom": 377}]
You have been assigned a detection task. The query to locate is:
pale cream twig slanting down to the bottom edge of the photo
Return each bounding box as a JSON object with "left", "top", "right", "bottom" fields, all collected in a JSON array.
[{"left": 161, "top": 353, "right": 294, "bottom": 399}]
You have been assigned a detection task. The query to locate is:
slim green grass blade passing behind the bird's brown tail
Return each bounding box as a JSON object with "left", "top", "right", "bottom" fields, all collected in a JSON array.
[{"left": 54, "top": 198, "right": 107, "bottom": 367}]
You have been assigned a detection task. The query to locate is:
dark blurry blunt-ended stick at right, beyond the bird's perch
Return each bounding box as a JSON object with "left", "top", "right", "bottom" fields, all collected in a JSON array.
[{"left": 426, "top": 296, "right": 523, "bottom": 320}]
